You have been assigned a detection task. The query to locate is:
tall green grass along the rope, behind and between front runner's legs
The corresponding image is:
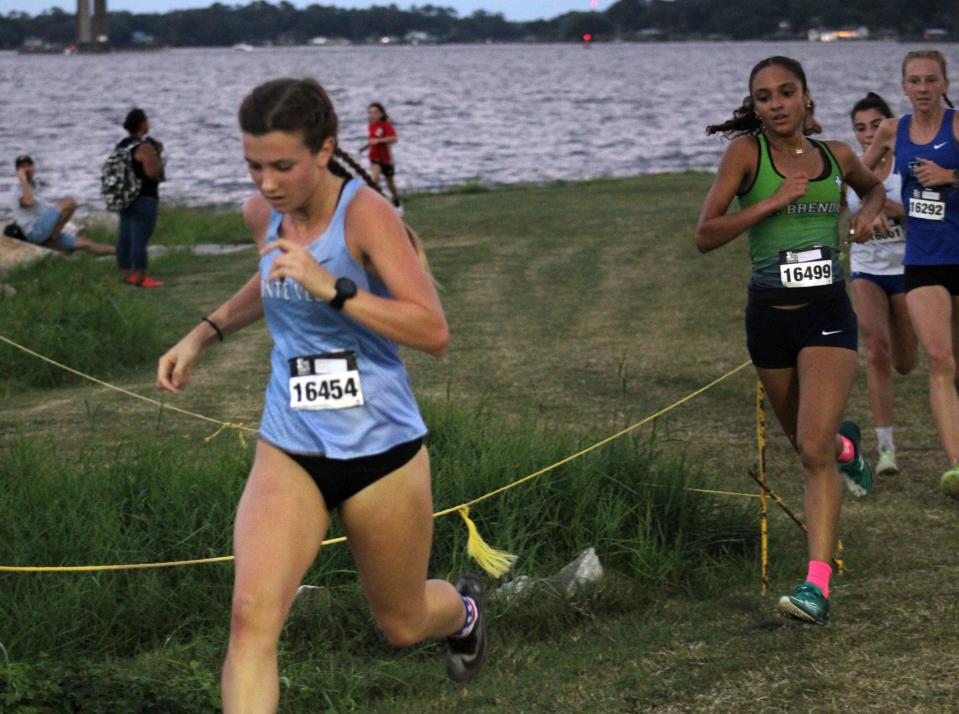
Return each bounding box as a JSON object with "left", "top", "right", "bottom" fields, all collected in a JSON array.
[{"left": 0, "top": 403, "right": 755, "bottom": 711}]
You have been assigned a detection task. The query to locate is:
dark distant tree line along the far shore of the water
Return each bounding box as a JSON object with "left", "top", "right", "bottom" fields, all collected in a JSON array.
[{"left": 0, "top": 0, "right": 959, "bottom": 49}]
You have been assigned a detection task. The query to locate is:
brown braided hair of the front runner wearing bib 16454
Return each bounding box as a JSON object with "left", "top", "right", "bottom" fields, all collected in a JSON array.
[{"left": 239, "top": 77, "right": 429, "bottom": 268}]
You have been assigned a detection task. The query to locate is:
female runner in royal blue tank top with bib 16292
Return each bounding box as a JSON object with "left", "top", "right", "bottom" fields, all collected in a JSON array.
[{"left": 863, "top": 50, "right": 959, "bottom": 493}]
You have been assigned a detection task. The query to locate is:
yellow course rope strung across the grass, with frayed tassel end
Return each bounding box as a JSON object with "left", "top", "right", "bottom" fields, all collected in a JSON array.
[{"left": 0, "top": 335, "right": 759, "bottom": 577}]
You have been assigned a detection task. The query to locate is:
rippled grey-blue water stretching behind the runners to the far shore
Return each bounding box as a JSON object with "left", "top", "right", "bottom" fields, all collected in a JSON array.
[{"left": 0, "top": 42, "right": 959, "bottom": 212}]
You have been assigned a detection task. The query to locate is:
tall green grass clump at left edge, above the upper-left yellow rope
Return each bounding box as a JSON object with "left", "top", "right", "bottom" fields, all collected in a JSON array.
[{"left": 0, "top": 259, "right": 173, "bottom": 388}]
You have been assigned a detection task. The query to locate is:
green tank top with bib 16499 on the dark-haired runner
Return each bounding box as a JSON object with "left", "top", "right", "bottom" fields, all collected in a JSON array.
[{"left": 738, "top": 134, "right": 844, "bottom": 304}]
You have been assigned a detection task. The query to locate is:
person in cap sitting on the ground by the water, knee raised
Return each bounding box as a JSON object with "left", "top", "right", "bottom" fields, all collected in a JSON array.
[{"left": 13, "top": 154, "right": 115, "bottom": 255}]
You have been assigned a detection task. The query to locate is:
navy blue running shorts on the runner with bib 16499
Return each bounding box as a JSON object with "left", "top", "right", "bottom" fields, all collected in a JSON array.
[{"left": 746, "top": 293, "right": 859, "bottom": 369}]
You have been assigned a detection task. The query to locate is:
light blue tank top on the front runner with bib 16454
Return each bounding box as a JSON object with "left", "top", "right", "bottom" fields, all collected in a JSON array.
[{"left": 260, "top": 179, "right": 426, "bottom": 459}]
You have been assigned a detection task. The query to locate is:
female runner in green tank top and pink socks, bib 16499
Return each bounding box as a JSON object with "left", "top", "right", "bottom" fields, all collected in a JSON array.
[{"left": 696, "top": 57, "right": 885, "bottom": 624}]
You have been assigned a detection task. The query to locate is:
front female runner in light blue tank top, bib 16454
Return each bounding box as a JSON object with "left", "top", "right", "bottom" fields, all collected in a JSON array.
[{"left": 158, "top": 79, "right": 486, "bottom": 714}]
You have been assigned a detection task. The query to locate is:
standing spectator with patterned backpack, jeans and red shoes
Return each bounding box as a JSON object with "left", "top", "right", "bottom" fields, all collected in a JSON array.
[{"left": 112, "top": 109, "right": 166, "bottom": 288}]
